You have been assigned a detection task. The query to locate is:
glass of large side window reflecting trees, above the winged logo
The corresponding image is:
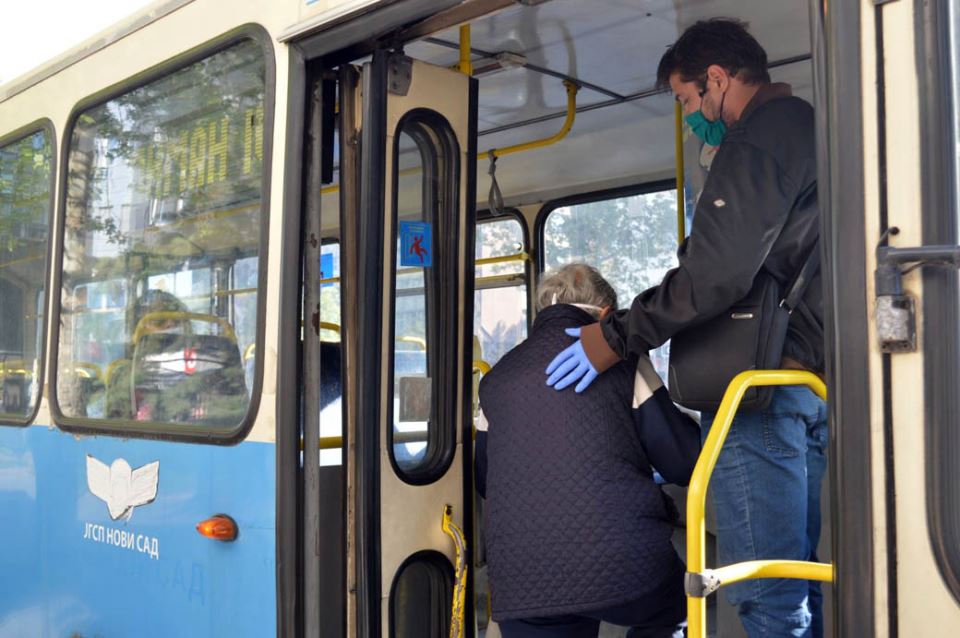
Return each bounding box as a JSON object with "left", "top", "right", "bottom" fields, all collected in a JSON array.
[{"left": 55, "top": 40, "right": 267, "bottom": 436}]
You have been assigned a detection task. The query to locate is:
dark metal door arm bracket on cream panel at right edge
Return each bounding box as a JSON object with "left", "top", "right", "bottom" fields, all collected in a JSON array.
[{"left": 873, "top": 227, "right": 960, "bottom": 353}]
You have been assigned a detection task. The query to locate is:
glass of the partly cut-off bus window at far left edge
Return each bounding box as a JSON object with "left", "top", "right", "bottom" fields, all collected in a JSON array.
[{"left": 0, "top": 130, "right": 52, "bottom": 424}]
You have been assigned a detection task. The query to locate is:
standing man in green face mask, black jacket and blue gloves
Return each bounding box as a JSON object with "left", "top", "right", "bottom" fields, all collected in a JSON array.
[{"left": 547, "top": 19, "right": 827, "bottom": 637}]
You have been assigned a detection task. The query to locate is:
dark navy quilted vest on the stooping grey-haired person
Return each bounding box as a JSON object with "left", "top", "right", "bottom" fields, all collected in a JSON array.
[{"left": 480, "top": 305, "right": 682, "bottom": 621}]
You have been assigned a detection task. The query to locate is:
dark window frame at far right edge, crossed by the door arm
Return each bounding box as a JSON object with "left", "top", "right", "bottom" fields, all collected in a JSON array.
[{"left": 920, "top": 4, "right": 960, "bottom": 602}]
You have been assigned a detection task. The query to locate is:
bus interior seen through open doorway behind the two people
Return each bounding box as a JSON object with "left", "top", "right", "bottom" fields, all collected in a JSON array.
[{"left": 305, "top": 0, "right": 831, "bottom": 637}]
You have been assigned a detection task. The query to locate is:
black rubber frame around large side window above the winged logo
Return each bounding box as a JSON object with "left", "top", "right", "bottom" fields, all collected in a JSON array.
[{"left": 49, "top": 23, "right": 277, "bottom": 445}]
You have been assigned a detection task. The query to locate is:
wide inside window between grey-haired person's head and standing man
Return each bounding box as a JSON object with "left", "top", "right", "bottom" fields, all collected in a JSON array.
[{"left": 540, "top": 187, "right": 677, "bottom": 382}]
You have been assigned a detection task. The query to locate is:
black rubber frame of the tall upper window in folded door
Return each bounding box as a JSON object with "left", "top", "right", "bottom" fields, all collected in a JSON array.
[{"left": 384, "top": 108, "right": 462, "bottom": 485}]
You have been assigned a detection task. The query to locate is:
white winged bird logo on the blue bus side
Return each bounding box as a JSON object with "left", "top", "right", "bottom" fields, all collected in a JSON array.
[{"left": 87, "top": 454, "right": 160, "bottom": 520}]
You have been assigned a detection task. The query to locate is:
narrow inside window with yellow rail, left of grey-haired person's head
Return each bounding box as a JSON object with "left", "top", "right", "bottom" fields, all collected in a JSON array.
[{"left": 473, "top": 217, "right": 527, "bottom": 365}]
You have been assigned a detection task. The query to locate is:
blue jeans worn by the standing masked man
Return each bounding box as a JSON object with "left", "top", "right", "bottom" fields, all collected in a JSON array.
[{"left": 701, "top": 386, "right": 828, "bottom": 638}]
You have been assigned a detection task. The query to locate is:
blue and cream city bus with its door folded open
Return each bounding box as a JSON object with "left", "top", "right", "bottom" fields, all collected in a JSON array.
[{"left": 0, "top": 0, "right": 960, "bottom": 638}]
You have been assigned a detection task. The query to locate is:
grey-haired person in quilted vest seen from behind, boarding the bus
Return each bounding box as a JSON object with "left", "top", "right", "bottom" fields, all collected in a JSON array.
[{"left": 476, "top": 264, "right": 699, "bottom": 638}]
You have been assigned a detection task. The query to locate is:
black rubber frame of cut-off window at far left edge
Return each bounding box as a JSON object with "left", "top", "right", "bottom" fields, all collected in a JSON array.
[{"left": 0, "top": 117, "right": 59, "bottom": 427}]
